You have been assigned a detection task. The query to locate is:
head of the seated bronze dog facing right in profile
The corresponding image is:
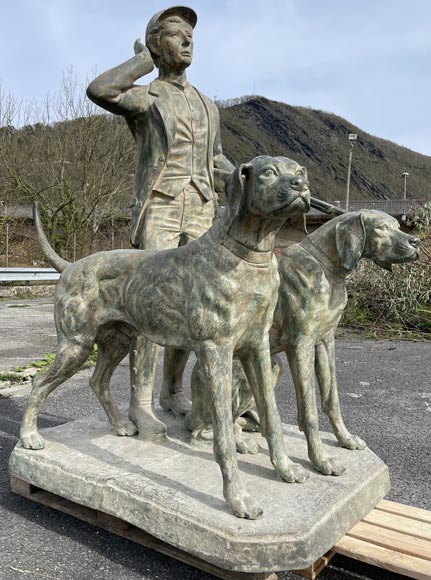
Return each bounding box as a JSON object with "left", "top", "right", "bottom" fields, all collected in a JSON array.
[{"left": 335, "top": 210, "right": 420, "bottom": 270}]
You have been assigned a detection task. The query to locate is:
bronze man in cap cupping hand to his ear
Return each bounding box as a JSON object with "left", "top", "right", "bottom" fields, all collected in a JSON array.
[{"left": 87, "top": 6, "right": 234, "bottom": 435}]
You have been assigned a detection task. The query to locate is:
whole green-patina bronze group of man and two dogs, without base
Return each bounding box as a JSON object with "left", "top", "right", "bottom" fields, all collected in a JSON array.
[{"left": 17, "top": 7, "right": 418, "bottom": 519}]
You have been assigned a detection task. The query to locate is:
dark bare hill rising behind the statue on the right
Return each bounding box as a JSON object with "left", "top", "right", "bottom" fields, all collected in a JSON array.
[{"left": 220, "top": 97, "right": 431, "bottom": 201}]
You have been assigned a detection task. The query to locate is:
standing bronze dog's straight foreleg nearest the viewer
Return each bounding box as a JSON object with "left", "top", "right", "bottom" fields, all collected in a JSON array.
[{"left": 197, "top": 345, "right": 263, "bottom": 520}]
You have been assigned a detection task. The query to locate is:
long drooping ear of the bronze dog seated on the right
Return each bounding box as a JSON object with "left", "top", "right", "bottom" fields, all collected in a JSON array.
[{"left": 335, "top": 212, "right": 365, "bottom": 270}]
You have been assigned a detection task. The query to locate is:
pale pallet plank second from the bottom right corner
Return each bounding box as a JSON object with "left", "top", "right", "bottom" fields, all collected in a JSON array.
[{"left": 347, "top": 521, "right": 431, "bottom": 561}]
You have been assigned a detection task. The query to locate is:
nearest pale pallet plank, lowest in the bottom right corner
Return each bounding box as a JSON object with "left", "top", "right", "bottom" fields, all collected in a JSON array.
[{"left": 334, "top": 536, "right": 431, "bottom": 580}]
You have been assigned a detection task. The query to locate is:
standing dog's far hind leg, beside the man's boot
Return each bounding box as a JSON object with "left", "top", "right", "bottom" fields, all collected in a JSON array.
[{"left": 90, "top": 330, "right": 137, "bottom": 436}]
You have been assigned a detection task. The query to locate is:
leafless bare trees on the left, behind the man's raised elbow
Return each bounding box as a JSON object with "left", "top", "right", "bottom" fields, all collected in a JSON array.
[{"left": 0, "top": 70, "right": 135, "bottom": 259}]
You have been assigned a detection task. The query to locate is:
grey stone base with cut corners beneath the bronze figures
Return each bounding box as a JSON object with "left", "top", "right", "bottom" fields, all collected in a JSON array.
[{"left": 10, "top": 410, "right": 390, "bottom": 572}]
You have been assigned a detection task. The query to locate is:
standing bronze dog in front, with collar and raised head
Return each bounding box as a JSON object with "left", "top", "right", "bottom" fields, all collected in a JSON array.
[{"left": 21, "top": 156, "right": 310, "bottom": 518}]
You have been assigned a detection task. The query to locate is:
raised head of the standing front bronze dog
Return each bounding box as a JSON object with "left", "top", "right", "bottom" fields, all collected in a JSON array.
[{"left": 227, "top": 155, "right": 310, "bottom": 219}]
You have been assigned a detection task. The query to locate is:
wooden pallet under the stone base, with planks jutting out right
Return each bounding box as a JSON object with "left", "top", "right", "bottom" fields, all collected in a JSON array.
[{"left": 11, "top": 476, "right": 431, "bottom": 580}]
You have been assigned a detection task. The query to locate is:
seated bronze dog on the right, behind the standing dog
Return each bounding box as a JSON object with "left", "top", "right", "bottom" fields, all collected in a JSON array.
[{"left": 186, "top": 210, "right": 419, "bottom": 475}]
